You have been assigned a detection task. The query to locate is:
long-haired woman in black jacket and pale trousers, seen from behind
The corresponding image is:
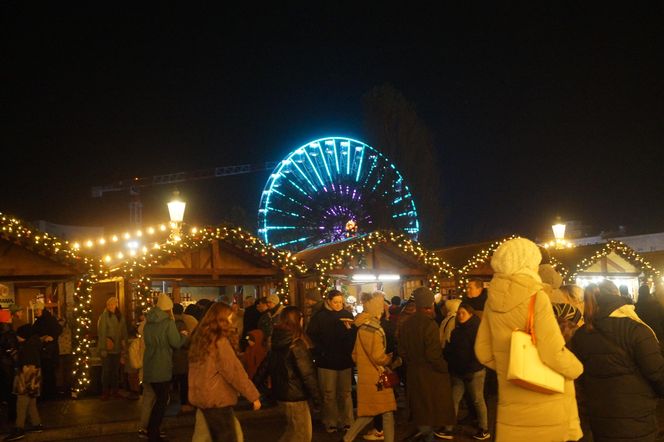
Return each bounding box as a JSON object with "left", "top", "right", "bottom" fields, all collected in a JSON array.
[{"left": 254, "top": 306, "right": 321, "bottom": 442}]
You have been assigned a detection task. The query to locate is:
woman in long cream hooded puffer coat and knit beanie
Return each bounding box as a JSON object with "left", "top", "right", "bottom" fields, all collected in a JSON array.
[{"left": 475, "top": 238, "right": 583, "bottom": 442}]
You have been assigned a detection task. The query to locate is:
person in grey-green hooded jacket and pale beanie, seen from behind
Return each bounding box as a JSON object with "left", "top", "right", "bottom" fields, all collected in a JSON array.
[{"left": 143, "top": 293, "right": 188, "bottom": 441}]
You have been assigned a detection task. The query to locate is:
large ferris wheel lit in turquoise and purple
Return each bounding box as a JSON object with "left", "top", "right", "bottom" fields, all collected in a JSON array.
[{"left": 258, "top": 137, "right": 420, "bottom": 250}]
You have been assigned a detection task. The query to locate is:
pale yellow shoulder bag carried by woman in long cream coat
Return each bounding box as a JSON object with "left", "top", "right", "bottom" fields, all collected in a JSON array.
[{"left": 507, "top": 294, "right": 565, "bottom": 394}]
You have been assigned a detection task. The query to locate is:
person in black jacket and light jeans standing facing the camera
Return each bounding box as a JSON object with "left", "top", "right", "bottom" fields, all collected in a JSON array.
[{"left": 307, "top": 290, "right": 356, "bottom": 433}]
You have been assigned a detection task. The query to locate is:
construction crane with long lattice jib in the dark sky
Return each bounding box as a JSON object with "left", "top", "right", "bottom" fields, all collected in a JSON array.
[{"left": 91, "top": 161, "right": 279, "bottom": 227}]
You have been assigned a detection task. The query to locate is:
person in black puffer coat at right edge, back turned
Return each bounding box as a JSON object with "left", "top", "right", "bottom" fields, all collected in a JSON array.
[{"left": 571, "top": 281, "right": 664, "bottom": 442}]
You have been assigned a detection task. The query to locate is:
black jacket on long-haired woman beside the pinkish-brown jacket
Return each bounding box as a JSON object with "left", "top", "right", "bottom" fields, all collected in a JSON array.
[{"left": 255, "top": 326, "right": 321, "bottom": 404}]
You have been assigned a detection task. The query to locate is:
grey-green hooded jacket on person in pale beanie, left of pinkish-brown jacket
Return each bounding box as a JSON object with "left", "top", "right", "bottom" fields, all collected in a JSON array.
[{"left": 143, "top": 307, "right": 187, "bottom": 382}]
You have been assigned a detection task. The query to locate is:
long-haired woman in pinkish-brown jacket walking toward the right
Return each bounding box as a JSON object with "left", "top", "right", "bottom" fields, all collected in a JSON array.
[{"left": 189, "top": 302, "right": 261, "bottom": 442}]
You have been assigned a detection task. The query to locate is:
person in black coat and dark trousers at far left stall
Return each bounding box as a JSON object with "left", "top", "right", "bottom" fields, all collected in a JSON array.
[{"left": 33, "top": 302, "right": 62, "bottom": 399}]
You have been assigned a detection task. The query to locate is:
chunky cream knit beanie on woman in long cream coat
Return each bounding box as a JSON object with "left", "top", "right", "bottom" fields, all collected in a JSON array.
[{"left": 491, "top": 238, "right": 542, "bottom": 282}]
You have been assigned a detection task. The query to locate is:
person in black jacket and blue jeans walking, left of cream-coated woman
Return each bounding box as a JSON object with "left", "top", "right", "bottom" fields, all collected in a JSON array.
[{"left": 443, "top": 302, "right": 491, "bottom": 440}]
